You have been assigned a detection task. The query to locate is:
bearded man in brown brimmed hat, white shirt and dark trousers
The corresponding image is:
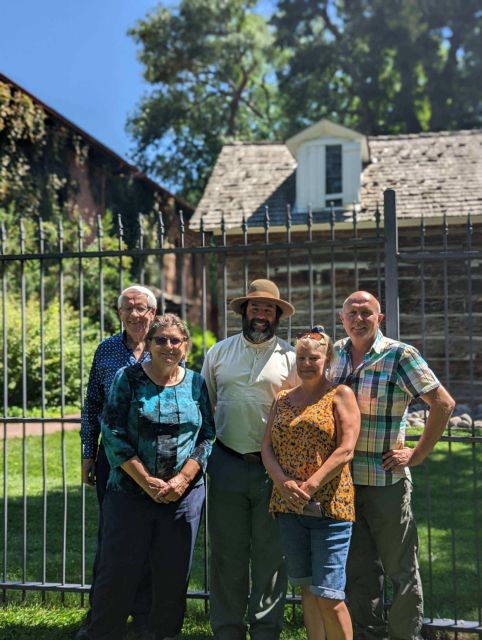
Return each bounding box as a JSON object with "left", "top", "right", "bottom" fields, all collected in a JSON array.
[{"left": 202, "top": 280, "right": 299, "bottom": 640}]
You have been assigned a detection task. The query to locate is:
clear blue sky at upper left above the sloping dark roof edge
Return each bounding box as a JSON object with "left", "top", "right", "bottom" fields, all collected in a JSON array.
[{"left": 0, "top": 0, "right": 156, "bottom": 157}]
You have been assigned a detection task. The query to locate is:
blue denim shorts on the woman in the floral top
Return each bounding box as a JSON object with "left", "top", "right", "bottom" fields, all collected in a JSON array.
[{"left": 276, "top": 513, "right": 352, "bottom": 600}]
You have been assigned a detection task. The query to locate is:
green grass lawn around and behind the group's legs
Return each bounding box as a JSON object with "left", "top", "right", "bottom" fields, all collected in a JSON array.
[{"left": 0, "top": 432, "right": 482, "bottom": 640}]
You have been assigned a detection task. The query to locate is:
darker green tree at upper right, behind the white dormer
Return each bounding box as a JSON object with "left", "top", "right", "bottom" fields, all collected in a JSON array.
[{"left": 272, "top": 0, "right": 482, "bottom": 135}]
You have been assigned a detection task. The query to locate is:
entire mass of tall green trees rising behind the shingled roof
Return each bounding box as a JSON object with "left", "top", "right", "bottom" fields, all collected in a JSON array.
[{"left": 129, "top": 0, "right": 482, "bottom": 203}]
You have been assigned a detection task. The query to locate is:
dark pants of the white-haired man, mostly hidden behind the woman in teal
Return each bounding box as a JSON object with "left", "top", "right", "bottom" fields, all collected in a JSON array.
[{"left": 89, "top": 443, "right": 151, "bottom": 619}]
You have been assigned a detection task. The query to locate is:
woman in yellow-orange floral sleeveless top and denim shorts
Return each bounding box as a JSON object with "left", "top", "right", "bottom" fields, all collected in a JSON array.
[{"left": 262, "top": 327, "right": 360, "bottom": 640}]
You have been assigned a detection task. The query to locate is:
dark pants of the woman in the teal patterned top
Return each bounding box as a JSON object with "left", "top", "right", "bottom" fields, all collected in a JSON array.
[{"left": 88, "top": 482, "right": 205, "bottom": 640}]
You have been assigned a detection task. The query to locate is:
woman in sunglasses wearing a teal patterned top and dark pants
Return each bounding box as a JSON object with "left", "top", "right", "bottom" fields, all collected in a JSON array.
[{"left": 87, "top": 313, "right": 215, "bottom": 640}]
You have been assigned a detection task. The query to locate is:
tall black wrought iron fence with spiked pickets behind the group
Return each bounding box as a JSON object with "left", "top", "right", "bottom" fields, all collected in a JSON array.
[{"left": 0, "top": 192, "right": 482, "bottom": 632}]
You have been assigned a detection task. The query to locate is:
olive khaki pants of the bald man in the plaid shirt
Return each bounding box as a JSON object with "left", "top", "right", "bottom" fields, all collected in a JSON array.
[{"left": 346, "top": 480, "right": 423, "bottom": 640}]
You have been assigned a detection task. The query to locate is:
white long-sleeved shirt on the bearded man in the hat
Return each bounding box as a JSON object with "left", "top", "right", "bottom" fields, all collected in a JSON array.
[{"left": 202, "top": 333, "right": 300, "bottom": 453}]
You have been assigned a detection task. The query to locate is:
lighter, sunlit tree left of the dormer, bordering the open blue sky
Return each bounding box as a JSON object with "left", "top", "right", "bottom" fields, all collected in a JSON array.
[{"left": 128, "top": 0, "right": 279, "bottom": 203}]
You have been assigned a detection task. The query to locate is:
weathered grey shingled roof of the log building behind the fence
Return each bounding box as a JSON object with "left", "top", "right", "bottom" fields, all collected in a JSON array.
[{"left": 191, "top": 129, "right": 482, "bottom": 229}]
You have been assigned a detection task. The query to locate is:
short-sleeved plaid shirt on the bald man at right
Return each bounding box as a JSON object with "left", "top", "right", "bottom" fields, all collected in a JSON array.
[{"left": 329, "top": 330, "right": 440, "bottom": 487}]
